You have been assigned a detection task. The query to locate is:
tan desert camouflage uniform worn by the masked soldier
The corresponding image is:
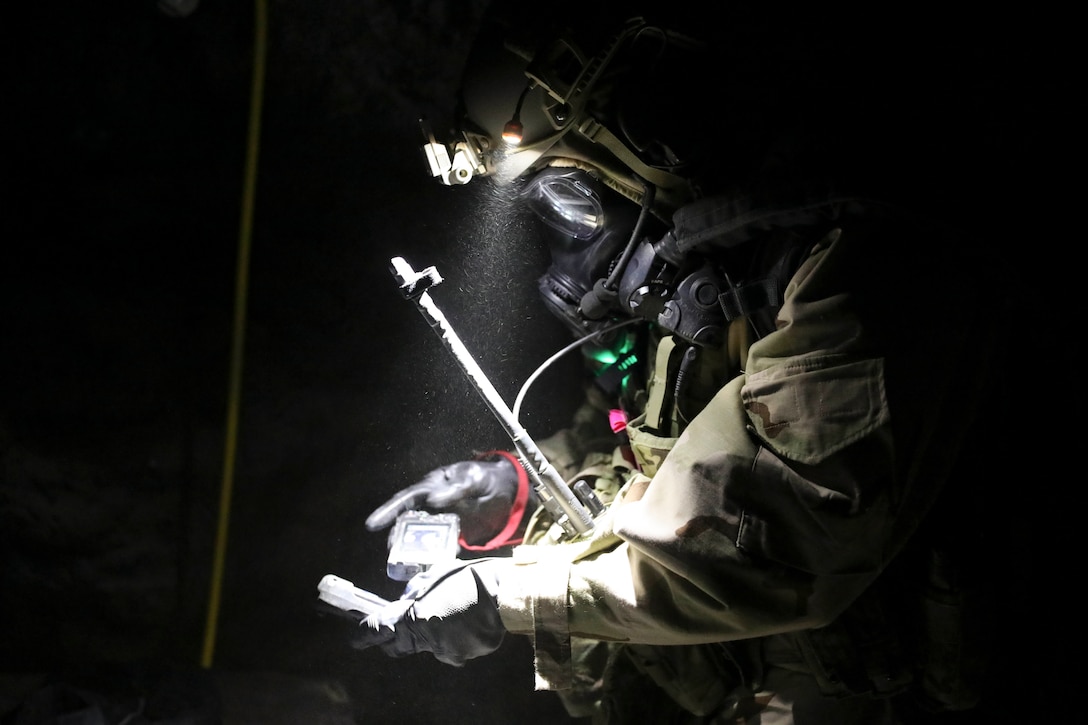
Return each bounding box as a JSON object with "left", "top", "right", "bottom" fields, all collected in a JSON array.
[{"left": 498, "top": 194, "right": 993, "bottom": 723}]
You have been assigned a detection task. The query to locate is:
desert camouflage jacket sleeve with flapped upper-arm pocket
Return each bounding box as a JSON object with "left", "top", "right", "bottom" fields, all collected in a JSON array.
[{"left": 499, "top": 222, "right": 996, "bottom": 689}]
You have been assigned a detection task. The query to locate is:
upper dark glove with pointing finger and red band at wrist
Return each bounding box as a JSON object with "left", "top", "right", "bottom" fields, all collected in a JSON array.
[{"left": 367, "top": 454, "right": 529, "bottom": 548}]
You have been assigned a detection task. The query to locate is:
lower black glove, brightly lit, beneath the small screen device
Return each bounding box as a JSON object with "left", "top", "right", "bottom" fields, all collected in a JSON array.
[{"left": 351, "top": 558, "right": 509, "bottom": 667}]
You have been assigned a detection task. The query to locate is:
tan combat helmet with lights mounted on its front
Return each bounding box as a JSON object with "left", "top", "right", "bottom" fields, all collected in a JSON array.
[{"left": 423, "top": 2, "right": 713, "bottom": 219}]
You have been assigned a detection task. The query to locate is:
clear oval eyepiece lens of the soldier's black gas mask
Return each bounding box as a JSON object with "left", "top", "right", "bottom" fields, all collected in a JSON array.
[{"left": 522, "top": 170, "right": 605, "bottom": 239}]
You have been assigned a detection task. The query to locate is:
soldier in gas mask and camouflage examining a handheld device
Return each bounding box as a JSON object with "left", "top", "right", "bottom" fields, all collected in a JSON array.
[{"left": 345, "top": 2, "right": 1001, "bottom": 725}]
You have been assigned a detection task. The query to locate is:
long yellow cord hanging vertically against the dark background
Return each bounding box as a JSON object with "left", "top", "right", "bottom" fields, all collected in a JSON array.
[{"left": 200, "top": 0, "right": 268, "bottom": 668}]
